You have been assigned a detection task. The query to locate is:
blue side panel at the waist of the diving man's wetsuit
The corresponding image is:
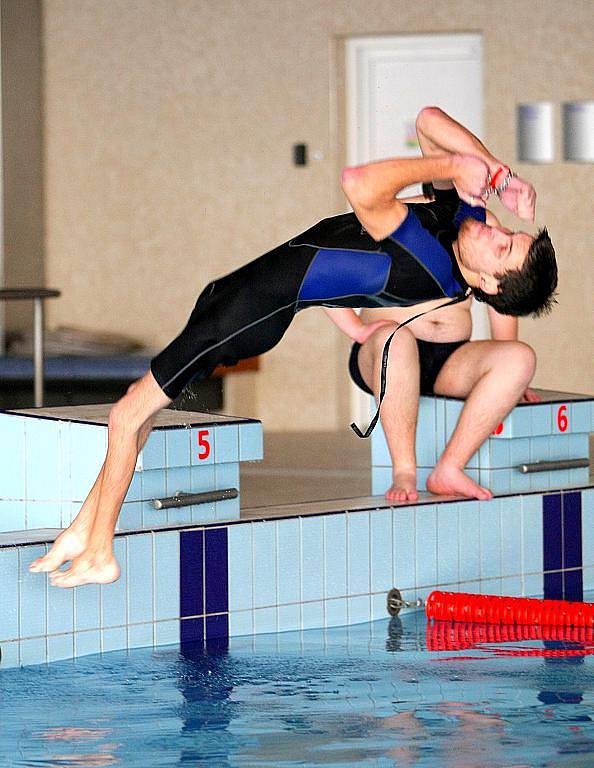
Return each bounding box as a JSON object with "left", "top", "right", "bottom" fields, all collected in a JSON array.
[{"left": 298, "top": 248, "right": 392, "bottom": 301}]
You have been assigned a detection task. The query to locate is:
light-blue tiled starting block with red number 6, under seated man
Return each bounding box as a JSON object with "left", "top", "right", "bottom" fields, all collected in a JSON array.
[{"left": 371, "top": 390, "right": 594, "bottom": 495}]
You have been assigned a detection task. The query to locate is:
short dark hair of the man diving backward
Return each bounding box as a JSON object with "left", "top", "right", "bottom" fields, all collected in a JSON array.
[{"left": 472, "top": 228, "right": 557, "bottom": 317}]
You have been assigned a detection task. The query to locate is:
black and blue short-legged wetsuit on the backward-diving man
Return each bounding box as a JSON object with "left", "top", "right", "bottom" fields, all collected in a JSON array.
[{"left": 151, "top": 190, "right": 485, "bottom": 399}]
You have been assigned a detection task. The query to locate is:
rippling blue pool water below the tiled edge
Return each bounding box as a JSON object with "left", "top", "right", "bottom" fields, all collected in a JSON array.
[{"left": 0, "top": 612, "right": 594, "bottom": 768}]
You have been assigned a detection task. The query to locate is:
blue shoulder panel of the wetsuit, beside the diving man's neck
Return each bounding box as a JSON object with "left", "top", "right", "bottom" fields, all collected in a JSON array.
[{"left": 390, "top": 206, "right": 470, "bottom": 298}]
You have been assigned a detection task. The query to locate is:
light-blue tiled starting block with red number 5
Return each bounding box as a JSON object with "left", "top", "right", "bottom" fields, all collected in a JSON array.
[{"left": 0, "top": 405, "right": 263, "bottom": 532}]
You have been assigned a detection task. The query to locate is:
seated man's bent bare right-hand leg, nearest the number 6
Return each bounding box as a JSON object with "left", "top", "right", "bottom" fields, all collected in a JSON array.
[{"left": 427, "top": 341, "right": 536, "bottom": 499}]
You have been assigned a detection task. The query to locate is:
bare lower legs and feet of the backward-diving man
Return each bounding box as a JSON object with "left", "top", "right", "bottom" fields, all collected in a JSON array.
[{"left": 31, "top": 372, "right": 171, "bottom": 587}]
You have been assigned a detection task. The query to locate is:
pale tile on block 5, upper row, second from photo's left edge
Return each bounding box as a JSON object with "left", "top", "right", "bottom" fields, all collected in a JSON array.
[{"left": 25, "top": 419, "right": 62, "bottom": 501}]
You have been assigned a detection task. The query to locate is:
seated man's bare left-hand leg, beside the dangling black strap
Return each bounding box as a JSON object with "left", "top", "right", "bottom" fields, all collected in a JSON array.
[{"left": 358, "top": 324, "right": 420, "bottom": 501}]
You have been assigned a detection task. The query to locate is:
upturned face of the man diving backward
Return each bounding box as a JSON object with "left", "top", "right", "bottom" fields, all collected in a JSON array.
[{"left": 458, "top": 218, "right": 534, "bottom": 293}]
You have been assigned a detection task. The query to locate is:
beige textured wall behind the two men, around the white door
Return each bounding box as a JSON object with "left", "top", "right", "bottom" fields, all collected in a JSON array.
[{"left": 43, "top": 0, "right": 594, "bottom": 429}]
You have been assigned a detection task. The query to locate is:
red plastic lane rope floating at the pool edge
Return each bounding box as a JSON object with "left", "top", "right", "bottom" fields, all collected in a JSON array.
[{"left": 425, "top": 591, "right": 594, "bottom": 628}]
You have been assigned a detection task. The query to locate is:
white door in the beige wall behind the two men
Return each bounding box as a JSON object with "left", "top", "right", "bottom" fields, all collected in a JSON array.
[{"left": 346, "top": 34, "right": 488, "bottom": 424}]
